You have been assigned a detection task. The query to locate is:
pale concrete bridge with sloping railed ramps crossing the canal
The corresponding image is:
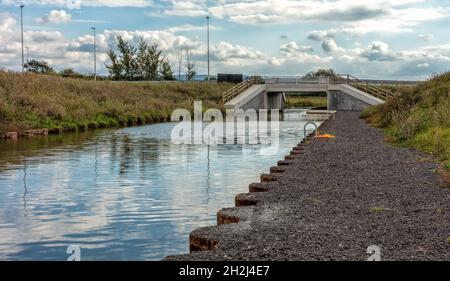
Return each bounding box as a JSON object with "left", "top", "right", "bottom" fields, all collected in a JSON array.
[{"left": 224, "top": 75, "right": 414, "bottom": 111}]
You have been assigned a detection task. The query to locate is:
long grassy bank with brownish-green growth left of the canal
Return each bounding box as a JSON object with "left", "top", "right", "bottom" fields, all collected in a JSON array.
[{"left": 0, "top": 71, "right": 231, "bottom": 132}]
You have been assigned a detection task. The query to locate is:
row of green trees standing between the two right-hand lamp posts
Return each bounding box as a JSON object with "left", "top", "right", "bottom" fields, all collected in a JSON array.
[{"left": 106, "top": 36, "right": 197, "bottom": 81}]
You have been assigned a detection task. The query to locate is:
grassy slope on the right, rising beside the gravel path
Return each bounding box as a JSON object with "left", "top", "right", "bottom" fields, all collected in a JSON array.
[{"left": 362, "top": 72, "right": 450, "bottom": 170}]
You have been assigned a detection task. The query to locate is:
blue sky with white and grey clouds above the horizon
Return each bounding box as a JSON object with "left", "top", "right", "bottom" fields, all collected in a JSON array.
[{"left": 0, "top": 0, "right": 450, "bottom": 80}]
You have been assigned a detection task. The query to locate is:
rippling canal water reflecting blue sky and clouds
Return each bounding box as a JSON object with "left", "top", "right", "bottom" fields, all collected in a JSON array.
[{"left": 0, "top": 115, "right": 318, "bottom": 260}]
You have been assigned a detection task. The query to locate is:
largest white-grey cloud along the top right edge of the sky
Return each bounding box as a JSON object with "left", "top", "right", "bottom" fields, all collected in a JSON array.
[{"left": 203, "top": 0, "right": 450, "bottom": 41}]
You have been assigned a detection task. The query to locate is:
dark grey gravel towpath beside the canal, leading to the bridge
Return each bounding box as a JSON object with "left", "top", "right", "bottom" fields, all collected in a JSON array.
[{"left": 166, "top": 112, "right": 450, "bottom": 261}]
